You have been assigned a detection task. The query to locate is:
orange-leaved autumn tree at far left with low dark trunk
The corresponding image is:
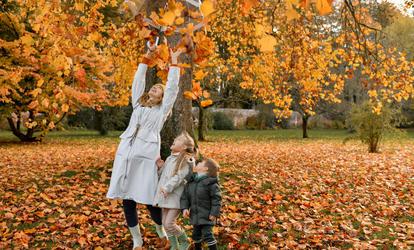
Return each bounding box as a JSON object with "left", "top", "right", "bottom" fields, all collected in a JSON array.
[{"left": 0, "top": 1, "right": 120, "bottom": 141}]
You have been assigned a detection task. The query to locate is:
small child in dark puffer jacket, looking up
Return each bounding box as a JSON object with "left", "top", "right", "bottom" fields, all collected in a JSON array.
[{"left": 181, "top": 159, "right": 221, "bottom": 250}]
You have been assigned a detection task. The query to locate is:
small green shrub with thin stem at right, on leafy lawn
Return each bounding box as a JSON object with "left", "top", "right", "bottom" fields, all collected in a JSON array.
[{"left": 345, "top": 102, "right": 402, "bottom": 153}]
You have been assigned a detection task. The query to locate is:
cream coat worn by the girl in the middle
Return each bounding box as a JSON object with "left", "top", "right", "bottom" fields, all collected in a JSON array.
[{"left": 153, "top": 155, "right": 195, "bottom": 209}]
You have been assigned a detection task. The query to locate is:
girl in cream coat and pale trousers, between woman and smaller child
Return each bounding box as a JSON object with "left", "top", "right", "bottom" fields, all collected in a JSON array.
[{"left": 154, "top": 132, "right": 195, "bottom": 249}]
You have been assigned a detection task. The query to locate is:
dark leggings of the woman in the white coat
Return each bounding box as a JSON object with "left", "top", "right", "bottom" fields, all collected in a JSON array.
[{"left": 122, "top": 200, "right": 162, "bottom": 227}]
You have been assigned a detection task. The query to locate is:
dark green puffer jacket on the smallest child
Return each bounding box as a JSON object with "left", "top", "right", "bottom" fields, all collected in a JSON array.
[{"left": 181, "top": 174, "right": 221, "bottom": 225}]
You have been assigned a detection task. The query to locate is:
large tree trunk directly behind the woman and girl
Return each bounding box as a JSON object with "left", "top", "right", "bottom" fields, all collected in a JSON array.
[{"left": 146, "top": 0, "right": 194, "bottom": 159}]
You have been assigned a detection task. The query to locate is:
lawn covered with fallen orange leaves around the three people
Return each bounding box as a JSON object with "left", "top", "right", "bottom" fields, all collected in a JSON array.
[{"left": 0, "top": 132, "right": 414, "bottom": 249}]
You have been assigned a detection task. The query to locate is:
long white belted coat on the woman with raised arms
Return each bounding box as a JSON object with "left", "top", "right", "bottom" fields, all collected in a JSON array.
[{"left": 107, "top": 63, "right": 180, "bottom": 205}]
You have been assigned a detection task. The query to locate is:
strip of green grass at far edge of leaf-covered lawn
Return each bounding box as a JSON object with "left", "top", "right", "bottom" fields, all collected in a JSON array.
[{"left": 0, "top": 129, "right": 414, "bottom": 142}]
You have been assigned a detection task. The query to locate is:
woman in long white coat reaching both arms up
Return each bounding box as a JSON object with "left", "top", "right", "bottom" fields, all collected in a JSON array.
[{"left": 107, "top": 45, "right": 182, "bottom": 249}]
